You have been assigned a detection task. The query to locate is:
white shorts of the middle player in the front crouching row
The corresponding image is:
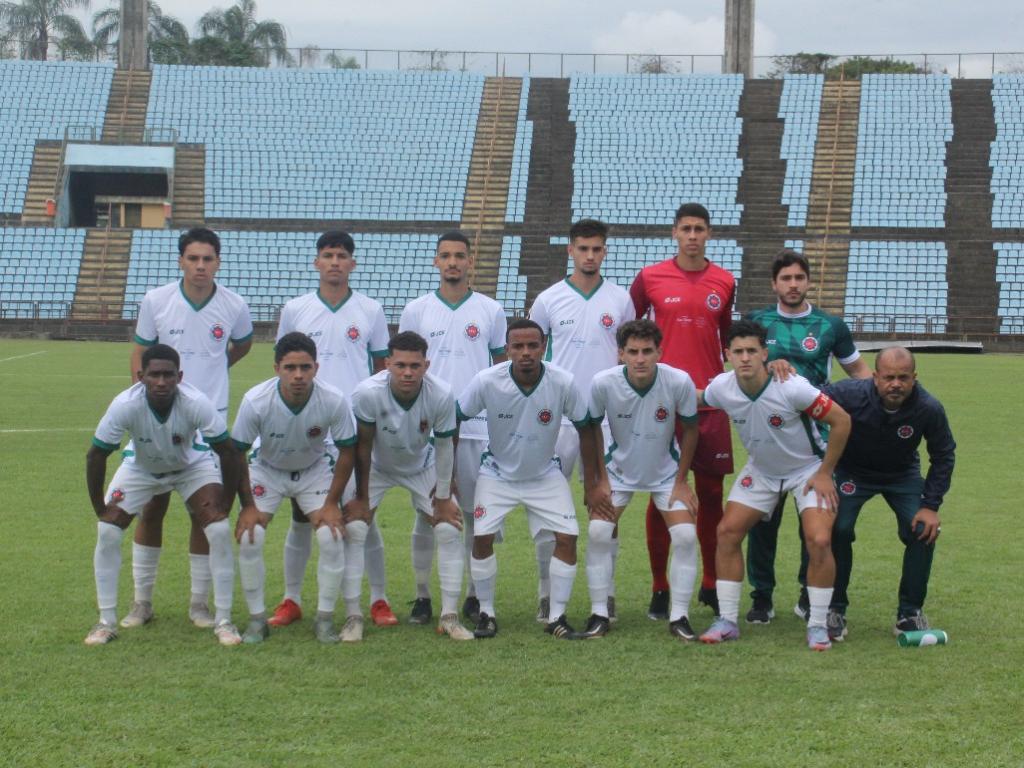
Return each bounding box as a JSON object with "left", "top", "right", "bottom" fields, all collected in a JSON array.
[{"left": 473, "top": 472, "right": 580, "bottom": 539}]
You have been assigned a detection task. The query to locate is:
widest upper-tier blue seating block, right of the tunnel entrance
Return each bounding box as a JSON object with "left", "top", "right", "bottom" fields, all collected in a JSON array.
[{"left": 146, "top": 66, "right": 484, "bottom": 221}]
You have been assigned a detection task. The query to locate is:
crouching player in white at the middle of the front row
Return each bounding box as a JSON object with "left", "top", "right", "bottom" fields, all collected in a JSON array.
[{"left": 458, "top": 318, "right": 597, "bottom": 639}]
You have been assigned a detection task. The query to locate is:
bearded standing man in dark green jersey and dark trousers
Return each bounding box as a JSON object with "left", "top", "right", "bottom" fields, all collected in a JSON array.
[{"left": 746, "top": 249, "right": 871, "bottom": 626}]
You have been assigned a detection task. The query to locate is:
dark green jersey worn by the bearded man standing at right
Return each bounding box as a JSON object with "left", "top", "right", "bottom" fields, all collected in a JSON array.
[{"left": 746, "top": 305, "right": 860, "bottom": 387}]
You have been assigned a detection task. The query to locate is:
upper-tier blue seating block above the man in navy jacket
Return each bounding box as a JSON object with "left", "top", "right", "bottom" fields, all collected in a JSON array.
[{"left": 851, "top": 75, "right": 953, "bottom": 227}]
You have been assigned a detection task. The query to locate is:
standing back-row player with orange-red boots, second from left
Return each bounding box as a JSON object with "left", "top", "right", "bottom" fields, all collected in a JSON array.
[{"left": 270, "top": 230, "right": 398, "bottom": 627}]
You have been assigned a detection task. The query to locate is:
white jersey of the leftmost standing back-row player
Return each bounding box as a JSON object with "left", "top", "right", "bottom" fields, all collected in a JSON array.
[{"left": 135, "top": 281, "right": 253, "bottom": 412}]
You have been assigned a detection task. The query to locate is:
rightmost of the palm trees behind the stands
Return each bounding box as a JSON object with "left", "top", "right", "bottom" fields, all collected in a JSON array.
[{"left": 193, "top": 0, "right": 293, "bottom": 67}]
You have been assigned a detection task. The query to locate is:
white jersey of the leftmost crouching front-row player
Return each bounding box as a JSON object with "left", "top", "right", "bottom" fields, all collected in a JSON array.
[{"left": 92, "top": 382, "right": 228, "bottom": 475}]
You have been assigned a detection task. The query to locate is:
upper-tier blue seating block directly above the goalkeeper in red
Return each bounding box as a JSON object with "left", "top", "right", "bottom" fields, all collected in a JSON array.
[{"left": 569, "top": 75, "right": 743, "bottom": 225}]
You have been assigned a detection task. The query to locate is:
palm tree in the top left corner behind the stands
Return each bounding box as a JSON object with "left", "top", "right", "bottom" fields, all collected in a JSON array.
[{"left": 0, "top": 0, "right": 89, "bottom": 61}]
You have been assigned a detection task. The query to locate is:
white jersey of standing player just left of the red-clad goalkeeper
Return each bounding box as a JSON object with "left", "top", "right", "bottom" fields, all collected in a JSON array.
[{"left": 529, "top": 278, "right": 637, "bottom": 424}]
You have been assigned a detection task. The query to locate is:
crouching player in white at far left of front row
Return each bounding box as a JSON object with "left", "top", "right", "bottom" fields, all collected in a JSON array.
[{"left": 85, "top": 344, "right": 244, "bottom": 645}]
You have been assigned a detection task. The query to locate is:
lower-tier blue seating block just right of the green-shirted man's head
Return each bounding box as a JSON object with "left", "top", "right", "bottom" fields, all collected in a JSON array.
[{"left": 844, "top": 241, "right": 948, "bottom": 334}]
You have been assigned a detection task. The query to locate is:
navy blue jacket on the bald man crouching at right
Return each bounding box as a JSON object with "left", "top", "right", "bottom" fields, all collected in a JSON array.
[{"left": 821, "top": 379, "right": 956, "bottom": 511}]
